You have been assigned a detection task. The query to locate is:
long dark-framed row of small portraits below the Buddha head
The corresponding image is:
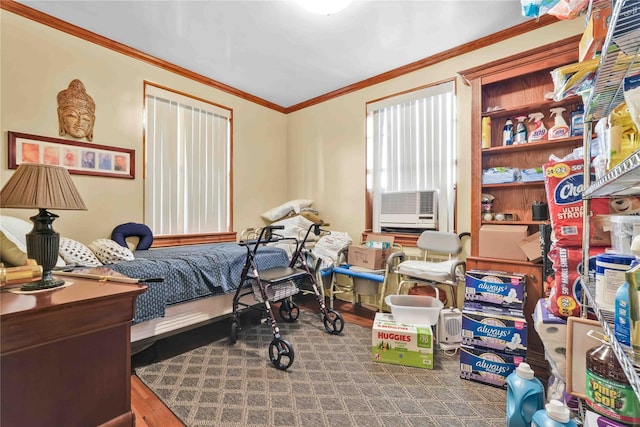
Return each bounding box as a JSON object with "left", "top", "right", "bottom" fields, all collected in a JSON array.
[{"left": 8, "top": 131, "right": 136, "bottom": 179}]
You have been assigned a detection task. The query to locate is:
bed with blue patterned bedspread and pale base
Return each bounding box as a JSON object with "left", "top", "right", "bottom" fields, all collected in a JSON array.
[{"left": 74, "top": 243, "right": 289, "bottom": 349}]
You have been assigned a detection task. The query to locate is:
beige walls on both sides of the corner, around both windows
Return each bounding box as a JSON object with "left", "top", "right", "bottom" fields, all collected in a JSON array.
[{"left": 0, "top": 10, "right": 584, "bottom": 243}]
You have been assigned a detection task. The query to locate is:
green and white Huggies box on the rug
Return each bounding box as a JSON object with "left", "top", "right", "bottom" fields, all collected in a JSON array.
[{"left": 371, "top": 313, "right": 433, "bottom": 369}]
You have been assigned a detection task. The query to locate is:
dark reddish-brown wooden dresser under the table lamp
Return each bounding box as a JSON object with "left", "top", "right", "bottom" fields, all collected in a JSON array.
[{"left": 0, "top": 277, "right": 146, "bottom": 427}]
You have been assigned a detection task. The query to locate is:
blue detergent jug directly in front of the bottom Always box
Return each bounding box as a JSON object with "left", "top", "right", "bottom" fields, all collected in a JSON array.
[{"left": 507, "top": 362, "right": 544, "bottom": 427}]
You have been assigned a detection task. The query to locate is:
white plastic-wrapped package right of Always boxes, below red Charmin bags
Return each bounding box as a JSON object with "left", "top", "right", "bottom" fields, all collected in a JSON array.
[{"left": 532, "top": 299, "right": 567, "bottom": 382}]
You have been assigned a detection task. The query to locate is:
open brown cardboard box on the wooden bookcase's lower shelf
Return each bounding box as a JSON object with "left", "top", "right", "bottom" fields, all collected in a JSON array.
[{"left": 479, "top": 224, "right": 527, "bottom": 261}]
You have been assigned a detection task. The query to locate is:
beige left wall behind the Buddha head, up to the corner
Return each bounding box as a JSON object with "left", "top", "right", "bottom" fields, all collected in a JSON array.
[{"left": 0, "top": 10, "right": 287, "bottom": 243}]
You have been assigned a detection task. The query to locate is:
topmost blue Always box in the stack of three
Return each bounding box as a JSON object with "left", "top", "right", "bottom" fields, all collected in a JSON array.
[{"left": 464, "top": 270, "right": 526, "bottom": 310}]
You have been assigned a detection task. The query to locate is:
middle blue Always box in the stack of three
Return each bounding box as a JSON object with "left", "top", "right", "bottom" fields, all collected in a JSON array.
[{"left": 462, "top": 307, "right": 527, "bottom": 357}]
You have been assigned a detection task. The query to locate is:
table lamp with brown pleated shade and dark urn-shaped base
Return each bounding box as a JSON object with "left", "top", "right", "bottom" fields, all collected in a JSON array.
[{"left": 0, "top": 163, "right": 87, "bottom": 291}]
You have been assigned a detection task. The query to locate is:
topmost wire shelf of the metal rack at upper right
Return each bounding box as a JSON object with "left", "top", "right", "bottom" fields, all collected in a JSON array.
[{"left": 584, "top": 0, "right": 640, "bottom": 121}]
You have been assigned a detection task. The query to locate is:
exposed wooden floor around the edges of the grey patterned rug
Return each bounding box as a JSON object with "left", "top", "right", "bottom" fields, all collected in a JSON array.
[{"left": 131, "top": 295, "right": 375, "bottom": 427}]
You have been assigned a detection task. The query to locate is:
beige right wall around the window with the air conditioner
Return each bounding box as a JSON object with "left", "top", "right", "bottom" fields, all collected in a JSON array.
[{"left": 287, "top": 19, "right": 584, "bottom": 244}]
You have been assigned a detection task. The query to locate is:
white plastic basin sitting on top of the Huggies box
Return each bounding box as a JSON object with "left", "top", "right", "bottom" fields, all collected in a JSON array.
[{"left": 384, "top": 295, "right": 444, "bottom": 325}]
